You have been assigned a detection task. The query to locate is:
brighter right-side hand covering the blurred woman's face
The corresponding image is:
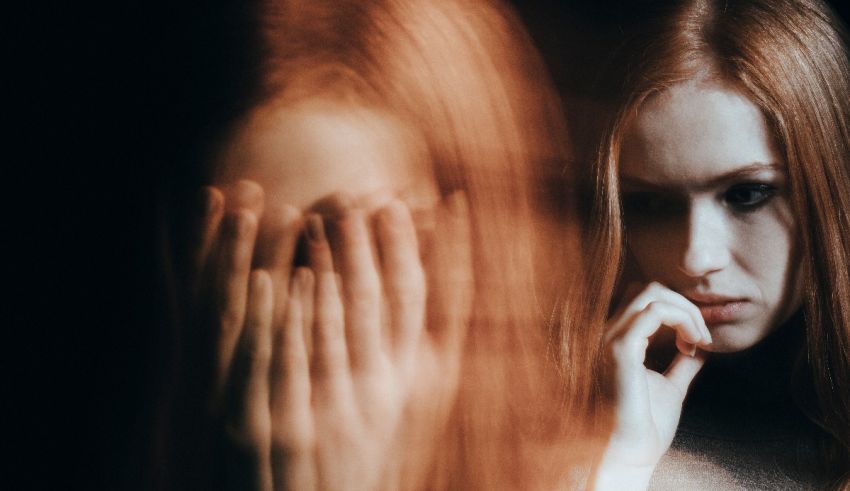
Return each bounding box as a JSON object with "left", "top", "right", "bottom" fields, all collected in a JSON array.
[{"left": 273, "top": 197, "right": 472, "bottom": 489}]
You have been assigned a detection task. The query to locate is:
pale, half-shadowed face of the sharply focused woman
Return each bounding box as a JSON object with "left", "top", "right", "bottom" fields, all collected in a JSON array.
[{"left": 620, "top": 82, "right": 801, "bottom": 352}]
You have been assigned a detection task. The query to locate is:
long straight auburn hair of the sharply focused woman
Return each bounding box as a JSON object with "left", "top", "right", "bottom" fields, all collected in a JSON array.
[{"left": 584, "top": 0, "right": 850, "bottom": 484}]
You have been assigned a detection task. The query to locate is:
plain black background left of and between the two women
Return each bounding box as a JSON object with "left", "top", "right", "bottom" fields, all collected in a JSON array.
[{"left": 13, "top": 0, "right": 848, "bottom": 489}]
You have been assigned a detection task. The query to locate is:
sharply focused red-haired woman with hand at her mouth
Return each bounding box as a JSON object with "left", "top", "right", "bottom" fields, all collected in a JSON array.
[{"left": 588, "top": 0, "right": 850, "bottom": 489}]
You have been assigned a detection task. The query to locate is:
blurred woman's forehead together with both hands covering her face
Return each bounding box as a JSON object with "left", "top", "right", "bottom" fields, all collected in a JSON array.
[{"left": 187, "top": 101, "right": 473, "bottom": 489}]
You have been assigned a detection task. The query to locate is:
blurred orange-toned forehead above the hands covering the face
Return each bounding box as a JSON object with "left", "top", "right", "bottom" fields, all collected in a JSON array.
[{"left": 217, "top": 100, "right": 431, "bottom": 213}]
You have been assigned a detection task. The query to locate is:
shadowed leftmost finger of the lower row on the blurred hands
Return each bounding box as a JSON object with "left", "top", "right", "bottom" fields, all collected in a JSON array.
[{"left": 222, "top": 270, "right": 272, "bottom": 489}]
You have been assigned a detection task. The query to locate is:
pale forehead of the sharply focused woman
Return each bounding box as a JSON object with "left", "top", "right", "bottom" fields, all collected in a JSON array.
[{"left": 620, "top": 82, "right": 779, "bottom": 186}]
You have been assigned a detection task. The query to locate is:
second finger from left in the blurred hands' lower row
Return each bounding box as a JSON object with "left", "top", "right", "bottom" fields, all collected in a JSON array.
[{"left": 271, "top": 268, "right": 315, "bottom": 489}]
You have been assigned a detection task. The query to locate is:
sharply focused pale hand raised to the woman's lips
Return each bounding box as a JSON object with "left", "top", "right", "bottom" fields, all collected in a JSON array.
[{"left": 596, "top": 283, "right": 711, "bottom": 489}]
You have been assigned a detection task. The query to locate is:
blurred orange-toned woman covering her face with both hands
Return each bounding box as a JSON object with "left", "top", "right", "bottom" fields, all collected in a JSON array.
[{"left": 161, "top": 0, "right": 596, "bottom": 489}]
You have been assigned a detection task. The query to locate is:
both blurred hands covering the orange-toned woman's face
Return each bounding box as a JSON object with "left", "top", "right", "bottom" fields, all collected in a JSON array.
[{"left": 190, "top": 182, "right": 473, "bottom": 489}]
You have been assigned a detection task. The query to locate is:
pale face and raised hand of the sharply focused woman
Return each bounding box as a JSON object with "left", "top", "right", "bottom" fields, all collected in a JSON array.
[{"left": 596, "top": 79, "right": 801, "bottom": 489}]
